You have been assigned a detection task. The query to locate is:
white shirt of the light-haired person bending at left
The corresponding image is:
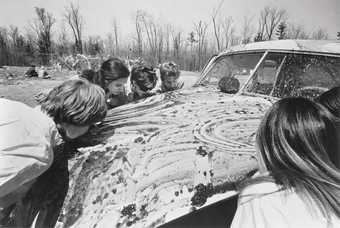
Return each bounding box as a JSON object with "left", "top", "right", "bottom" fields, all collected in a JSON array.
[{"left": 0, "top": 98, "right": 57, "bottom": 199}]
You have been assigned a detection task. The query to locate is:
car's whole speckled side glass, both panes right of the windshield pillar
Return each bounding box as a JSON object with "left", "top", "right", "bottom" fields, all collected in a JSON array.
[{"left": 244, "top": 53, "right": 340, "bottom": 98}]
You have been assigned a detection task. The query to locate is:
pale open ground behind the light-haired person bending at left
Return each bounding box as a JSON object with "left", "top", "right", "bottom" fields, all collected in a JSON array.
[{"left": 0, "top": 66, "right": 76, "bottom": 106}]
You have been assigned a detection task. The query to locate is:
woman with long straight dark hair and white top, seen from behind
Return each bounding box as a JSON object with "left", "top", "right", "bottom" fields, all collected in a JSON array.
[{"left": 232, "top": 98, "right": 340, "bottom": 228}]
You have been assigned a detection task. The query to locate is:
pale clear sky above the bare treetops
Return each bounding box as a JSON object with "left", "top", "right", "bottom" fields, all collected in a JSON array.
[{"left": 0, "top": 0, "right": 340, "bottom": 38}]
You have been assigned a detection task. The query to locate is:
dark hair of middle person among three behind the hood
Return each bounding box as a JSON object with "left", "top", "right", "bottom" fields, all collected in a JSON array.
[{"left": 130, "top": 65, "right": 157, "bottom": 91}]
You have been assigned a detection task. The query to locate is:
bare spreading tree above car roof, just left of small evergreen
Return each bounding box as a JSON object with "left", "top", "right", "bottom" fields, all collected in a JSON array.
[{"left": 256, "top": 6, "right": 287, "bottom": 41}]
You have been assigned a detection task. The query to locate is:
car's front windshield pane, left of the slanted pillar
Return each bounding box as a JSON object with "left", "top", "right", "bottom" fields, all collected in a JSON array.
[{"left": 199, "top": 52, "right": 264, "bottom": 91}]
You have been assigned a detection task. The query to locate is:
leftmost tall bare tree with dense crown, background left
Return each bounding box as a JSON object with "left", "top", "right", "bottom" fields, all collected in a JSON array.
[{"left": 32, "top": 7, "right": 56, "bottom": 64}]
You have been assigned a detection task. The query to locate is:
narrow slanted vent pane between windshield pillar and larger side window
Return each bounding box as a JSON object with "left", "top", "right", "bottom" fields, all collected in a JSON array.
[{"left": 246, "top": 53, "right": 285, "bottom": 95}]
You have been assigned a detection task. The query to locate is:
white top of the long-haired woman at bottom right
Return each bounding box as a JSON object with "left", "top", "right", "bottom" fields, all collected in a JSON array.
[{"left": 231, "top": 182, "right": 340, "bottom": 228}]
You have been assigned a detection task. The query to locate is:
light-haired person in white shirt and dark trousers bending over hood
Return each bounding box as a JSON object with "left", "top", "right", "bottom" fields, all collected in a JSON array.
[{"left": 0, "top": 79, "right": 107, "bottom": 228}]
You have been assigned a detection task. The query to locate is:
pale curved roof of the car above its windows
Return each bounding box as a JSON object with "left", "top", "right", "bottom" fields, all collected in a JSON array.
[{"left": 222, "top": 40, "right": 340, "bottom": 55}]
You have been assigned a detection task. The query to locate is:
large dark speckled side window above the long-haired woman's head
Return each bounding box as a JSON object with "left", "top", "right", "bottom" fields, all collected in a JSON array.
[{"left": 273, "top": 54, "right": 340, "bottom": 98}]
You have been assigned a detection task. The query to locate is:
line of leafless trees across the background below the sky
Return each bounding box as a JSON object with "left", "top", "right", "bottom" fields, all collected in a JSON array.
[{"left": 0, "top": 3, "right": 340, "bottom": 71}]
